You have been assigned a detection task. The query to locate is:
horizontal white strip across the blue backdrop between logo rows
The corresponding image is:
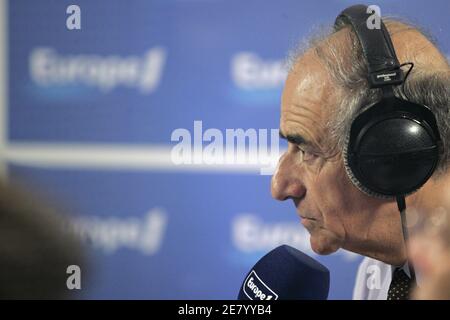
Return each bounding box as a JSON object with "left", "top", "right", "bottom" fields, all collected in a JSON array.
[{"left": 5, "top": 142, "right": 282, "bottom": 173}]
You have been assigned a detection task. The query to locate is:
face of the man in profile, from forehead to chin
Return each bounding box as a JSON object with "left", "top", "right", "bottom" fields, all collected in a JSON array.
[{"left": 272, "top": 52, "right": 400, "bottom": 260}]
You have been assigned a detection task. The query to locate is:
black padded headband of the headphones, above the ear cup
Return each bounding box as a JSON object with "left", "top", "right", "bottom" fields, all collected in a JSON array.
[{"left": 335, "top": 4, "right": 404, "bottom": 88}]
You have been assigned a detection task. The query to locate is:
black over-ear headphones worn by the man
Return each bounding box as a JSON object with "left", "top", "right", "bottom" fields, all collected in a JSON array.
[{"left": 335, "top": 5, "right": 442, "bottom": 199}]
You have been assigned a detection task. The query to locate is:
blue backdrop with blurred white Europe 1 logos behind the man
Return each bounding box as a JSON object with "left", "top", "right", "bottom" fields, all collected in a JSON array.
[{"left": 5, "top": 0, "right": 450, "bottom": 299}]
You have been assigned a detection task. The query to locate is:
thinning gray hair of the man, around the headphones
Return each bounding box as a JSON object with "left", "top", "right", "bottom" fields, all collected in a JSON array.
[{"left": 287, "top": 18, "right": 450, "bottom": 176}]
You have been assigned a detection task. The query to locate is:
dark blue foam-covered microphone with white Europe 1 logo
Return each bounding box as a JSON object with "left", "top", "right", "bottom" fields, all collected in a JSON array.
[{"left": 238, "top": 245, "right": 330, "bottom": 300}]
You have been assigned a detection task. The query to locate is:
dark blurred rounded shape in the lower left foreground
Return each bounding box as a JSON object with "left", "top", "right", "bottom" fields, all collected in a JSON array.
[{"left": 0, "top": 183, "right": 85, "bottom": 299}]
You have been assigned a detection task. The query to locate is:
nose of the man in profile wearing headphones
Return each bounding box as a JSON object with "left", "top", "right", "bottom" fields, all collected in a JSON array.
[{"left": 271, "top": 153, "right": 306, "bottom": 201}]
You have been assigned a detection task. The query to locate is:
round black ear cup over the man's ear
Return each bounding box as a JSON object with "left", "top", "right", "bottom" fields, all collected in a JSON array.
[{"left": 343, "top": 98, "right": 440, "bottom": 198}]
